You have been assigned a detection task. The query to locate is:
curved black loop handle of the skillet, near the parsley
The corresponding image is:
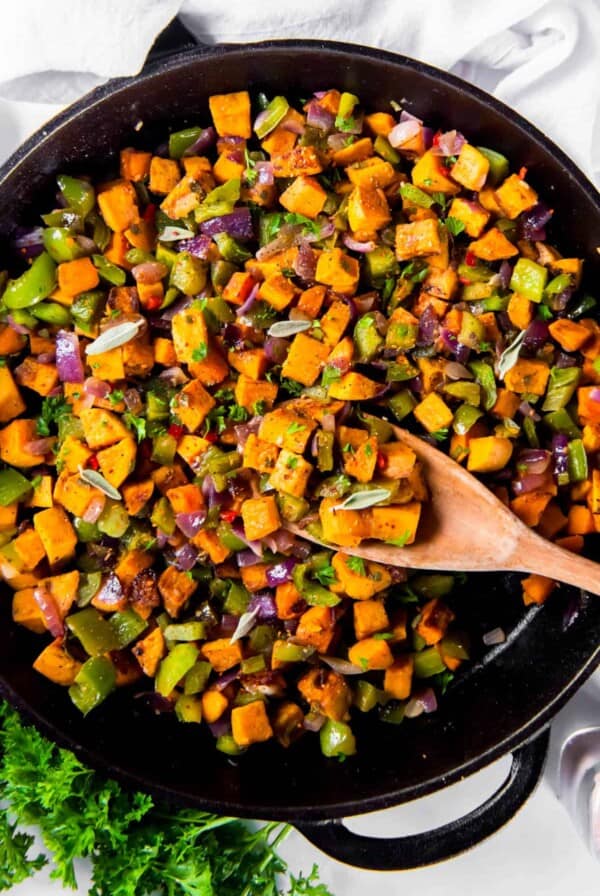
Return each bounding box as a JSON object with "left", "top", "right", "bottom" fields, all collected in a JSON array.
[{"left": 296, "top": 730, "right": 549, "bottom": 871}]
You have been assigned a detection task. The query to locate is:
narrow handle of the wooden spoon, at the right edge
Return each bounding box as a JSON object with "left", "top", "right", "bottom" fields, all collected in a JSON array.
[{"left": 511, "top": 533, "right": 600, "bottom": 594}]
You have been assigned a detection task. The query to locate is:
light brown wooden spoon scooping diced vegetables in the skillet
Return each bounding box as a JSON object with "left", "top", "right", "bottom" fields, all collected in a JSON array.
[{"left": 286, "top": 426, "right": 600, "bottom": 594}]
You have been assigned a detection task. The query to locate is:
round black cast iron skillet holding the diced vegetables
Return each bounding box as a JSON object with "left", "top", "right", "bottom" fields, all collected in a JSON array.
[{"left": 0, "top": 19, "right": 600, "bottom": 870}]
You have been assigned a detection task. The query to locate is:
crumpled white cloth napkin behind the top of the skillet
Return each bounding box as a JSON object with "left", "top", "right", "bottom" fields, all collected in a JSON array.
[{"left": 0, "top": 0, "right": 600, "bottom": 182}]
